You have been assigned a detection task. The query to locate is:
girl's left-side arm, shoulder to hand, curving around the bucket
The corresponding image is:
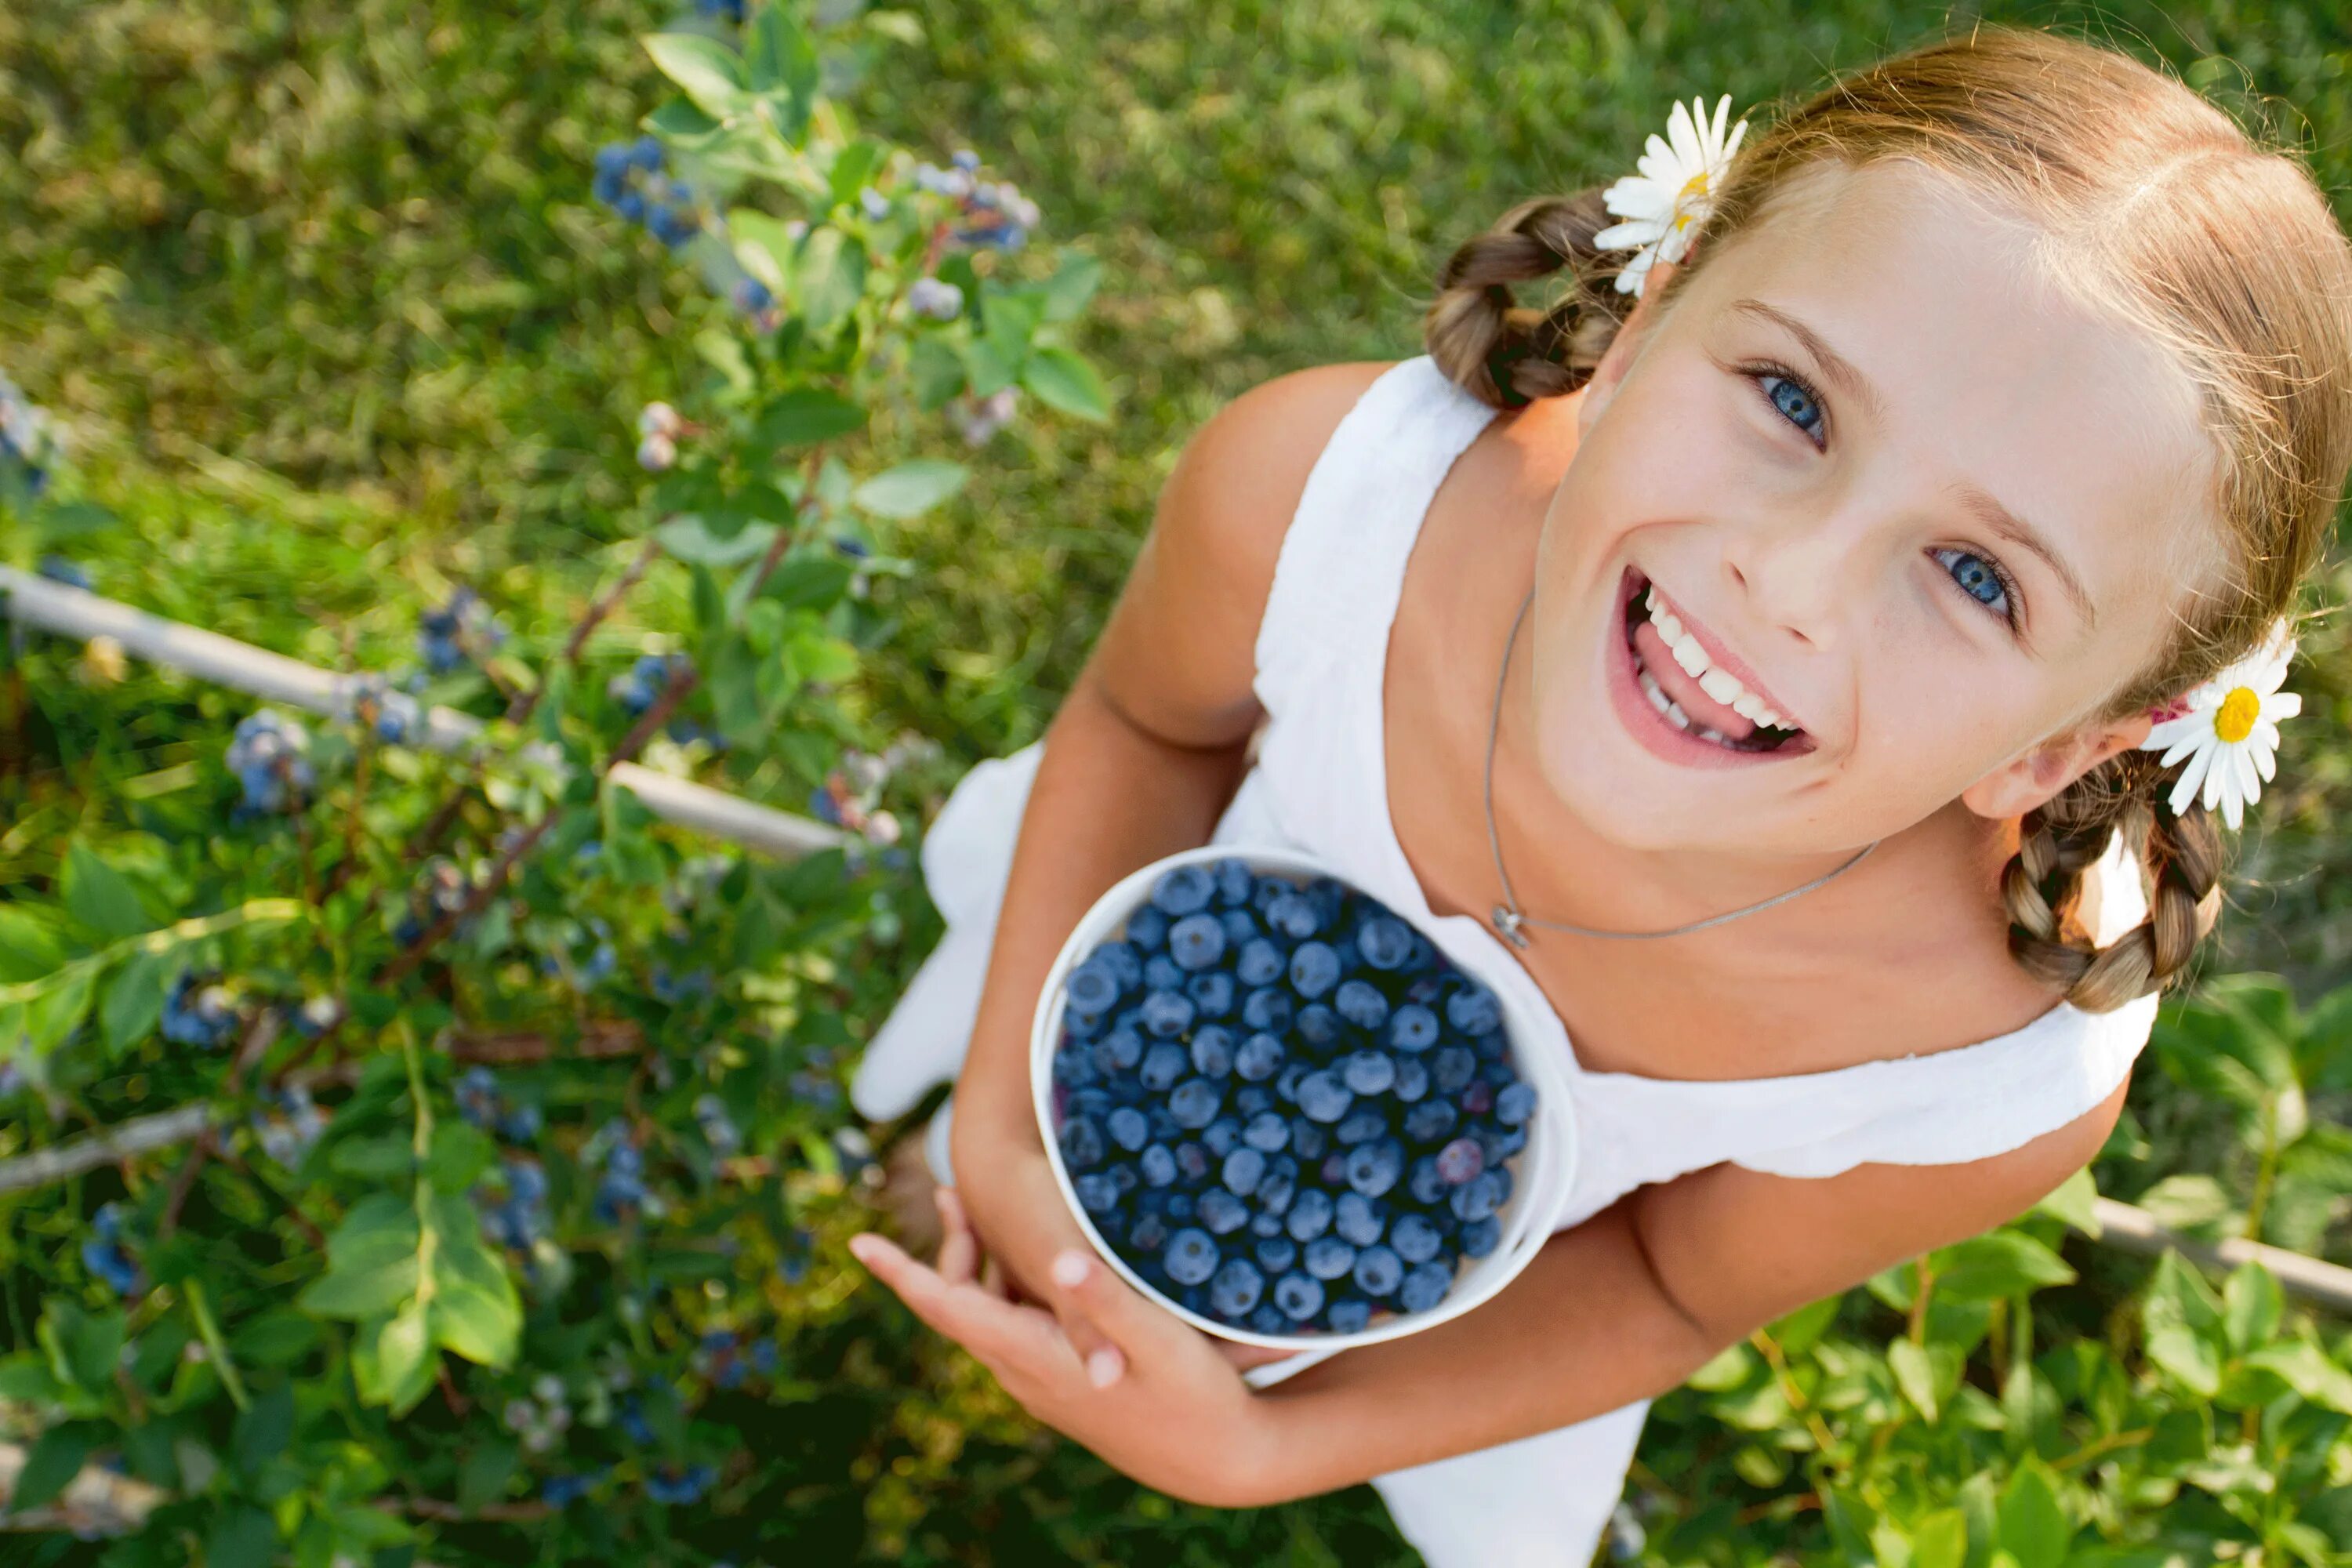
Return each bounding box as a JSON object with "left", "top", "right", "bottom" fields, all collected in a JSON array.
[{"left": 950, "top": 365, "right": 1385, "bottom": 1300}]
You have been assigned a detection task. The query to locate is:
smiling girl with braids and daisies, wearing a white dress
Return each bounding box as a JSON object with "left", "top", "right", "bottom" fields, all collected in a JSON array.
[{"left": 837, "top": 28, "right": 2352, "bottom": 1568}]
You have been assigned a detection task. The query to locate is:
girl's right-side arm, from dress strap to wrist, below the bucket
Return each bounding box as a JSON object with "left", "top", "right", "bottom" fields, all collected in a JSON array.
[{"left": 1235, "top": 1079, "right": 2129, "bottom": 1507}]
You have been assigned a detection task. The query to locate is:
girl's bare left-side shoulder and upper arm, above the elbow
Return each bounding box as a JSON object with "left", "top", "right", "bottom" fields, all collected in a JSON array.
[{"left": 1089, "top": 362, "right": 1390, "bottom": 748}]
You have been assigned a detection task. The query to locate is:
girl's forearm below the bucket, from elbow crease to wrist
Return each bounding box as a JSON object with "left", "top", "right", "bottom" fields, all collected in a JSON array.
[{"left": 1249, "top": 1201, "right": 1722, "bottom": 1504}]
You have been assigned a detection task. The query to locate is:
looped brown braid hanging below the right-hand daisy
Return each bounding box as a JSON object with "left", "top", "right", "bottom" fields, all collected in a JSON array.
[{"left": 2002, "top": 753, "right": 2220, "bottom": 1013}]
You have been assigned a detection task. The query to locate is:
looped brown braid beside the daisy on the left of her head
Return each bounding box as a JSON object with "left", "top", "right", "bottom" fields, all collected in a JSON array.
[{"left": 1421, "top": 186, "right": 1625, "bottom": 409}]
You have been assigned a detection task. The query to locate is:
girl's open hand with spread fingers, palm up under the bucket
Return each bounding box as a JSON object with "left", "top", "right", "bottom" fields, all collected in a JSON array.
[{"left": 849, "top": 1187, "right": 1284, "bottom": 1507}]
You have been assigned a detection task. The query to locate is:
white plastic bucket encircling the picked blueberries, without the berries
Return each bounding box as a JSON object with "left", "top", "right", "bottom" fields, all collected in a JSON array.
[{"left": 1030, "top": 844, "right": 1576, "bottom": 1349}]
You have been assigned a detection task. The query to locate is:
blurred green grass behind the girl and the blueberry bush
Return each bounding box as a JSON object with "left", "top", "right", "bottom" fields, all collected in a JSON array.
[{"left": 0, "top": 0, "right": 2352, "bottom": 1563}]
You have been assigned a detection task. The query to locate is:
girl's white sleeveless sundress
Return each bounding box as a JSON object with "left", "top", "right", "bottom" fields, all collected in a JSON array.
[{"left": 851, "top": 355, "right": 2157, "bottom": 1568}]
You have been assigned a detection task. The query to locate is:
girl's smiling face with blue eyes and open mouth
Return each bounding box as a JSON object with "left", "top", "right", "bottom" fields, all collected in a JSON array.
[{"left": 1522, "top": 162, "right": 2220, "bottom": 853}]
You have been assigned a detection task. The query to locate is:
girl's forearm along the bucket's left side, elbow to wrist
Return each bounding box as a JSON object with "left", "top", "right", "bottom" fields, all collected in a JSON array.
[{"left": 953, "top": 675, "right": 1247, "bottom": 1147}]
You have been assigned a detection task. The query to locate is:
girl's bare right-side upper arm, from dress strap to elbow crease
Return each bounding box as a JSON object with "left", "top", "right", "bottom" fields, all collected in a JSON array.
[{"left": 1625, "top": 1074, "right": 2131, "bottom": 1345}]
